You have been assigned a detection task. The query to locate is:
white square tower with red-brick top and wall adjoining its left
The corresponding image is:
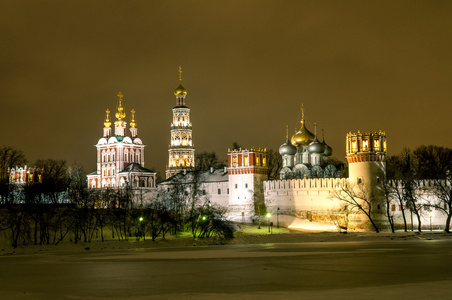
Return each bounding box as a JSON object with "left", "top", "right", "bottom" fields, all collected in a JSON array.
[{"left": 158, "top": 148, "right": 268, "bottom": 222}]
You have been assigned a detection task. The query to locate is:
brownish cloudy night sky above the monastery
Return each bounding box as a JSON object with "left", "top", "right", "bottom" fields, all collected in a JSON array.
[{"left": 0, "top": 0, "right": 452, "bottom": 177}]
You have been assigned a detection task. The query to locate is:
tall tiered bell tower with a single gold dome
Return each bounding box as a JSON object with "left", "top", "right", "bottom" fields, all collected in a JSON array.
[{"left": 166, "top": 66, "right": 195, "bottom": 179}]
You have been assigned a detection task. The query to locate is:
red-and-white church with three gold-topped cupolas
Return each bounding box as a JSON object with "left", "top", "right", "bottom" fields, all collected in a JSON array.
[{"left": 87, "top": 92, "right": 156, "bottom": 188}]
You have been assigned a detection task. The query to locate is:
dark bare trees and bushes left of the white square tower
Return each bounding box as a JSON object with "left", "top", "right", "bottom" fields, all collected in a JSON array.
[{"left": 0, "top": 146, "right": 233, "bottom": 247}]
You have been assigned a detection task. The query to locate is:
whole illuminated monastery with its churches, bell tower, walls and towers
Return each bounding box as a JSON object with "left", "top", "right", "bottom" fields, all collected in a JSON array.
[{"left": 77, "top": 69, "right": 444, "bottom": 229}]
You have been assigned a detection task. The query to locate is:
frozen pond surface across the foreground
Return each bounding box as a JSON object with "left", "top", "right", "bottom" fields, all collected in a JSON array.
[{"left": 0, "top": 240, "right": 452, "bottom": 299}]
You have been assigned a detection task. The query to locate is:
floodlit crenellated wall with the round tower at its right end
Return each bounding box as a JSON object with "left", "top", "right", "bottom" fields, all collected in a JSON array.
[{"left": 264, "top": 129, "right": 386, "bottom": 230}]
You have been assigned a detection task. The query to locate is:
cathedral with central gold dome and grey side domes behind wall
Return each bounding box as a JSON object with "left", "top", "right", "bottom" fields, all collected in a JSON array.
[{"left": 279, "top": 106, "right": 339, "bottom": 179}]
